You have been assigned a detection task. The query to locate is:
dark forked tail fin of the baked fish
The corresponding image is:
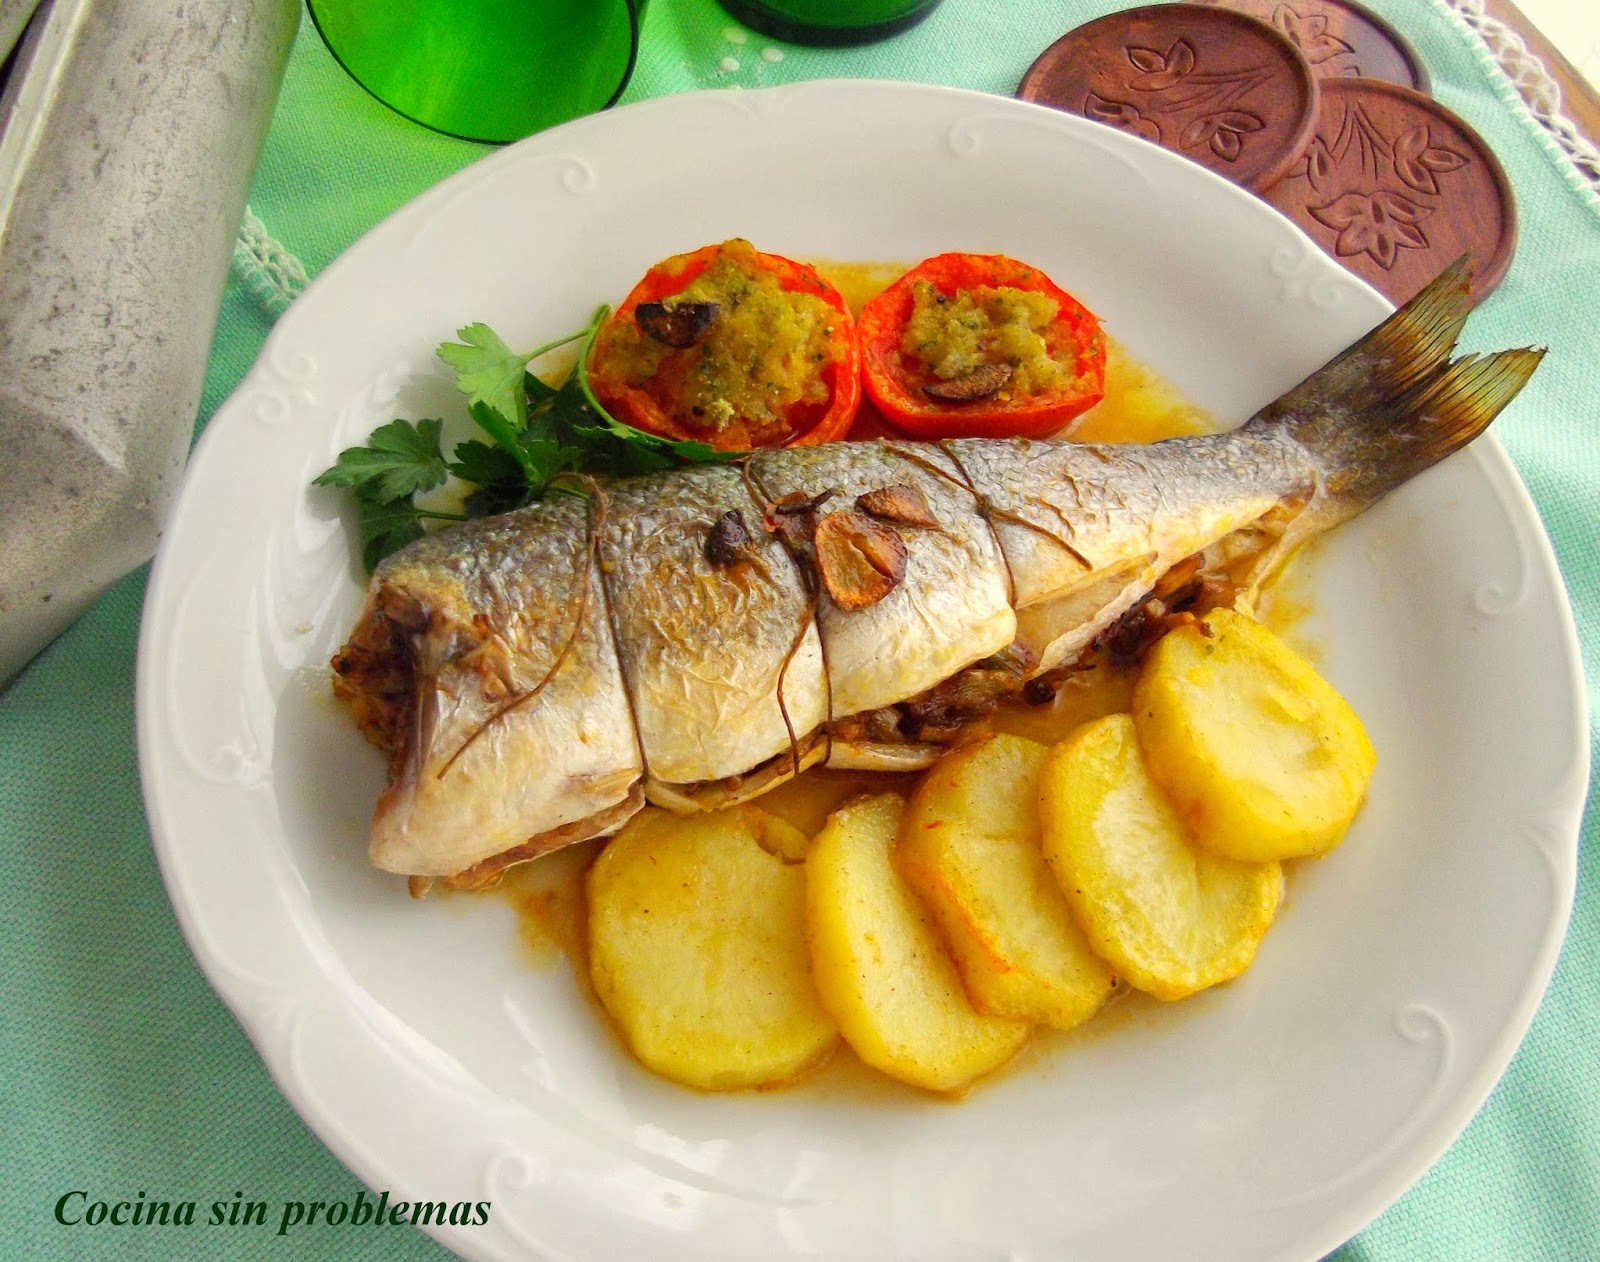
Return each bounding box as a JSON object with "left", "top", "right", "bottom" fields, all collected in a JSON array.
[{"left": 1250, "top": 258, "right": 1544, "bottom": 520}]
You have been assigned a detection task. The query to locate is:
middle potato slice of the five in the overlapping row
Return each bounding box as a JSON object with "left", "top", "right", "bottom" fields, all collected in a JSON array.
[{"left": 894, "top": 736, "right": 1115, "bottom": 1030}]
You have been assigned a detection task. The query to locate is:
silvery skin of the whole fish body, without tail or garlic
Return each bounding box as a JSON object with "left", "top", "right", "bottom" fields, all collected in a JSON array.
[{"left": 360, "top": 435, "right": 1309, "bottom": 875}]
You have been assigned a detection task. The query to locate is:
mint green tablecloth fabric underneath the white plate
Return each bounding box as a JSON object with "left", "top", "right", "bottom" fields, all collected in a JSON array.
[{"left": 0, "top": 0, "right": 1600, "bottom": 1262}]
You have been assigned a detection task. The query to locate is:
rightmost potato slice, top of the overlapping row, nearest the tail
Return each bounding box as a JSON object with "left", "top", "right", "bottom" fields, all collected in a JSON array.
[{"left": 1133, "top": 609, "right": 1376, "bottom": 862}]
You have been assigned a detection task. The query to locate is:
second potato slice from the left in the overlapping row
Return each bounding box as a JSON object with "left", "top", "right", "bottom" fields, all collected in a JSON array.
[{"left": 805, "top": 793, "right": 1029, "bottom": 1091}]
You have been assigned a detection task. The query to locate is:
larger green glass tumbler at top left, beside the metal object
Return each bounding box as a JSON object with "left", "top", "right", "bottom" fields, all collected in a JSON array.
[{"left": 307, "top": 0, "right": 645, "bottom": 144}]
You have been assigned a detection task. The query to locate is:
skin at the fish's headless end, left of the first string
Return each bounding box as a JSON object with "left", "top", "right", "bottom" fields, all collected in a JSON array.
[{"left": 363, "top": 497, "right": 643, "bottom": 877}]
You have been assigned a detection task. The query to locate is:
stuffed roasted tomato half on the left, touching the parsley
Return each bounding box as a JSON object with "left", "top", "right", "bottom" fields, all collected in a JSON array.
[{"left": 589, "top": 240, "right": 861, "bottom": 451}]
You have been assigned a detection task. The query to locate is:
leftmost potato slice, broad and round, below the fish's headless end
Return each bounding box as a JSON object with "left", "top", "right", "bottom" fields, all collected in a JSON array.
[{"left": 587, "top": 806, "right": 838, "bottom": 1091}]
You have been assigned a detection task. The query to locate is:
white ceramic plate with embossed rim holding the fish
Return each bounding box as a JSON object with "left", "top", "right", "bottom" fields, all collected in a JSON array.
[{"left": 139, "top": 83, "right": 1589, "bottom": 1262}]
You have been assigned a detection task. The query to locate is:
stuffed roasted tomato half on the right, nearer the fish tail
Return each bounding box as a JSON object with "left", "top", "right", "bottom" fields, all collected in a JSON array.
[{"left": 858, "top": 254, "right": 1106, "bottom": 438}]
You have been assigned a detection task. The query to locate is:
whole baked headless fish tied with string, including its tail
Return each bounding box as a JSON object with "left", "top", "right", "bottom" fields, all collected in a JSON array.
[{"left": 333, "top": 264, "right": 1542, "bottom": 888}]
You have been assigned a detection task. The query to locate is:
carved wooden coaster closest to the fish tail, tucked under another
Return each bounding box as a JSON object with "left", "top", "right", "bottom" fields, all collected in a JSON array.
[{"left": 1262, "top": 78, "right": 1517, "bottom": 304}]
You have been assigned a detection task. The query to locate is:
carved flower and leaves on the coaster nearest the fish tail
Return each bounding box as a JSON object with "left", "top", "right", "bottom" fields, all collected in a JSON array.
[{"left": 1296, "top": 102, "right": 1470, "bottom": 269}]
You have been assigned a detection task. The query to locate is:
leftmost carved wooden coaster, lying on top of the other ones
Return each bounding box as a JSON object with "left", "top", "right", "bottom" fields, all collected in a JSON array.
[{"left": 1016, "top": 3, "right": 1317, "bottom": 192}]
